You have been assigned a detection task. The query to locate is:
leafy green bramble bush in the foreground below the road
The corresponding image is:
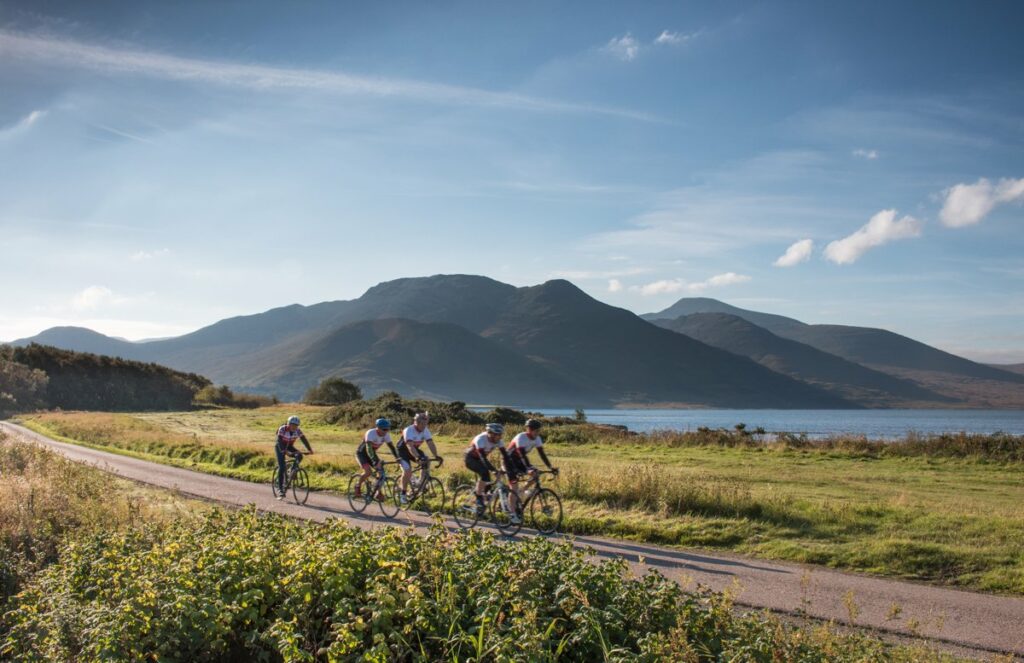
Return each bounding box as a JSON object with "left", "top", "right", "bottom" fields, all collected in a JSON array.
[{"left": 0, "top": 510, "right": 942, "bottom": 662}]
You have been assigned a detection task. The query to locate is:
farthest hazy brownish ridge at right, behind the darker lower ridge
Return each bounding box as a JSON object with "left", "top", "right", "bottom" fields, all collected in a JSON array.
[{"left": 644, "top": 298, "right": 1024, "bottom": 408}]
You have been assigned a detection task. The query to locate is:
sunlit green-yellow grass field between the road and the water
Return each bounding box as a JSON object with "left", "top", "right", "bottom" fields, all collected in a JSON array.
[{"left": 16, "top": 406, "right": 1024, "bottom": 594}]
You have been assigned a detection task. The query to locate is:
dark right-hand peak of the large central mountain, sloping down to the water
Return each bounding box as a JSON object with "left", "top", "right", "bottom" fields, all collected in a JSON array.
[{"left": 481, "top": 280, "right": 853, "bottom": 408}]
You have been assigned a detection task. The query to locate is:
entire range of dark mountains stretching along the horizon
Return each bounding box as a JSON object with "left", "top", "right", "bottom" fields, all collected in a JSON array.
[{"left": 14, "top": 275, "right": 1024, "bottom": 408}]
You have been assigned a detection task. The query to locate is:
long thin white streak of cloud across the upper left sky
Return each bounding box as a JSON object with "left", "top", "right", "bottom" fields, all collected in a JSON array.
[{"left": 0, "top": 31, "right": 654, "bottom": 121}]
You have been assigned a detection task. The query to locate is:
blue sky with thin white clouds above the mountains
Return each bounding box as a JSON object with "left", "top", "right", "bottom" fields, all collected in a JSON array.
[{"left": 0, "top": 0, "right": 1024, "bottom": 362}]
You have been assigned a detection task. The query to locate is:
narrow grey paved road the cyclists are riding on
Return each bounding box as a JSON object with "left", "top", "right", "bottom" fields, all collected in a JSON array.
[{"left": 0, "top": 422, "right": 1024, "bottom": 656}]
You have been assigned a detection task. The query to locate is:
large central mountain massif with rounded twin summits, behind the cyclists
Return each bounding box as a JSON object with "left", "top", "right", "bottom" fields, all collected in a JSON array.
[{"left": 9, "top": 275, "right": 855, "bottom": 408}]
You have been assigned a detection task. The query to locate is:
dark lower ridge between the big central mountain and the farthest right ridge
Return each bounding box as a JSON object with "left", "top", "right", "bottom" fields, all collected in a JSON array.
[{"left": 653, "top": 313, "right": 961, "bottom": 407}]
